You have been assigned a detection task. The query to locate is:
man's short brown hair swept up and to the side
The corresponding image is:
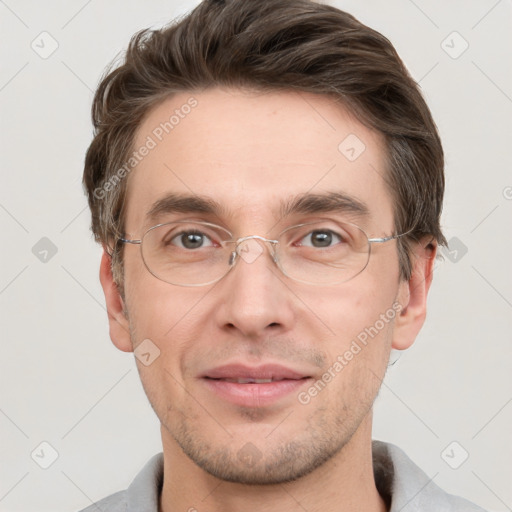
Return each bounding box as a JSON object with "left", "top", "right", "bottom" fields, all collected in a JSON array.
[{"left": 83, "top": 0, "right": 446, "bottom": 284}]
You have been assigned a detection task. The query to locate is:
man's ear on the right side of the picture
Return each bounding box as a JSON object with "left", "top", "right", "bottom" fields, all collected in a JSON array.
[{"left": 391, "top": 237, "right": 437, "bottom": 350}]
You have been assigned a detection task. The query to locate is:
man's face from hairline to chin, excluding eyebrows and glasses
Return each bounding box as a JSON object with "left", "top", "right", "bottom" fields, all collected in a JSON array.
[{"left": 119, "top": 89, "right": 406, "bottom": 483}]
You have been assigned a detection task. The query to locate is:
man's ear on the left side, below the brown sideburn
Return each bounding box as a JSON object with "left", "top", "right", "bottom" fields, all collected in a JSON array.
[{"left": 100, "top": 249, "right": 133, "bottom": 352}]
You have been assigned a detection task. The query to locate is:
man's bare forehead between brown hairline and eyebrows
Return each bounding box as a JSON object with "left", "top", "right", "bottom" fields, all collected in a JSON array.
[{"left": 125, "top": 88, "right": 393, "bottom": 232}]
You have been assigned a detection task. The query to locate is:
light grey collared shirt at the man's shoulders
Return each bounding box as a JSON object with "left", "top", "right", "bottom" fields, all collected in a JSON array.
[{"left": 77, "top": 441, "right": 485, "bottom": 512}]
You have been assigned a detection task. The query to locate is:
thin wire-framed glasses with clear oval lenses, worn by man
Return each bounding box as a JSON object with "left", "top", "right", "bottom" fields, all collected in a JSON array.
[{"left": 119, "top": 219, "right": 409, "bottom": 286}]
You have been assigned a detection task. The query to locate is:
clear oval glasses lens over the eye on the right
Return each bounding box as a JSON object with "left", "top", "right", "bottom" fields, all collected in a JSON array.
[{"left": 277, "top": 219, "right": 370, "bottom": 285}]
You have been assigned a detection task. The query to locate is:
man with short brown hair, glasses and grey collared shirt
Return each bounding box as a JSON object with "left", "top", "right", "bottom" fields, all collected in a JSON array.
[{"left": 84, "top": 0, "right": 488, "bottom": 512}]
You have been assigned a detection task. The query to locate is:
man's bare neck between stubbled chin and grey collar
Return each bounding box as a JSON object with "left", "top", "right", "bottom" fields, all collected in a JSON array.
[{"left": 159, "top": 414, "right": 387, "bottom": 512}]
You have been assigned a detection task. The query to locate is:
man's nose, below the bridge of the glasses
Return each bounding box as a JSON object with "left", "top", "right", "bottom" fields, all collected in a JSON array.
[{"left": 216, "top": 237, "right": 294, "bottom": 338}]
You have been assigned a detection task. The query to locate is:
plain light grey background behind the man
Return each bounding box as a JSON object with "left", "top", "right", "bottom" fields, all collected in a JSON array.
[{"left": 0, "top": 0, "right": 512, "bottom": 512}]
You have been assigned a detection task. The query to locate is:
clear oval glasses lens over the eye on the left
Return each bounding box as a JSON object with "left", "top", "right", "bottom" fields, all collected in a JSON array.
[{"left": 142, "top": 221, "right": 231, "bottom": 286}]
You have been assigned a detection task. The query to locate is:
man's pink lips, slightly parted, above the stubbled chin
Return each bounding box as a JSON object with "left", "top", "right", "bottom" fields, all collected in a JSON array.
[{"left": 201, "top": 364, "right": 311, "bottom": 407}]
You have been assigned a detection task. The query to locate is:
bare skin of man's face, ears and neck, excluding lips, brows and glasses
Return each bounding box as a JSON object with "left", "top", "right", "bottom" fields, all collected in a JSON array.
[{"left": 100, "top": 88, "right": 436, "bottom": 512}]
